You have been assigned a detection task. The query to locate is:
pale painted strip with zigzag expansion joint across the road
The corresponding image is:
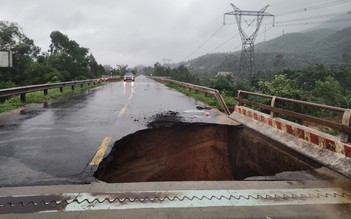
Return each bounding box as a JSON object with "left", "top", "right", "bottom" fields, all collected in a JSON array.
[{"left": 0, "top": 188, "right": 351, "bottom": 214}]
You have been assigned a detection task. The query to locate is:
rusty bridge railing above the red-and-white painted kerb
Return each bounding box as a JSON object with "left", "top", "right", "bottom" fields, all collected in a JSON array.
[{"left": 235, "top": 90, "right": 351, "bottom": 143}]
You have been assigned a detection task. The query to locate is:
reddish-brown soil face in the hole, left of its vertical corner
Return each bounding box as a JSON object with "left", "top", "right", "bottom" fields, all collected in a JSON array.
[{"left": 96, "top": 124, "right": 234, "bottom": 182}]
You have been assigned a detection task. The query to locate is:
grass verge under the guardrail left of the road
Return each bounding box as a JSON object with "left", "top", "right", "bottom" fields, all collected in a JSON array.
[{"left": 0, "top": 84, "right": 102, "bottom": 113}]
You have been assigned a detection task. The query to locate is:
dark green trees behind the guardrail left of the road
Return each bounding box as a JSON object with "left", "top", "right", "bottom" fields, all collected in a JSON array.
[{"left": 0, "top": 21, "right": 106, "bottom": 89}]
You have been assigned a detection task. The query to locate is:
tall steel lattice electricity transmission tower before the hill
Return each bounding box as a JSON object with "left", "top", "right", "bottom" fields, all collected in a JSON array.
[{"left": 224, "top": 4, "right": 274, "bottom": 78}]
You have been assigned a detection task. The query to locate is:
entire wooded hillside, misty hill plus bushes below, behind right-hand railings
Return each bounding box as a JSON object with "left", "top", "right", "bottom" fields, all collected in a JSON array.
[{"left": 151, "top": 27, "right": 351, "bottom": 111}]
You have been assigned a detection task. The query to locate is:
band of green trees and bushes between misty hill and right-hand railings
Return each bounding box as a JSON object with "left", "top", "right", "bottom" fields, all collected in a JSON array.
[{"left": 153, "top": 64, "right": 351, "bottom": 108}]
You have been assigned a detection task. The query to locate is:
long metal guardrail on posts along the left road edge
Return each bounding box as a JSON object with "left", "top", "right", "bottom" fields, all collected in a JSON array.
[{"left": 0, "top": 79, "right": 101, "bottom": 102}]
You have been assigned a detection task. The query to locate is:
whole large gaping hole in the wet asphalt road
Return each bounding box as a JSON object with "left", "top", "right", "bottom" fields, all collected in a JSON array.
[{"left": 94, "top": 122, "right": 320, "bottom": 183}]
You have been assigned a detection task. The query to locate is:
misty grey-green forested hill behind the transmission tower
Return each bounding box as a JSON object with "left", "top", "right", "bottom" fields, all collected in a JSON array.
[{"left": 187, "top": 27, "right": 351, "bottom": 75}]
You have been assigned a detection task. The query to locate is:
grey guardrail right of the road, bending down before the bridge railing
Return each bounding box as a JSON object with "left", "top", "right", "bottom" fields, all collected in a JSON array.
[{"left": 152, "top": 77, "right": 230, "bottom": 115}]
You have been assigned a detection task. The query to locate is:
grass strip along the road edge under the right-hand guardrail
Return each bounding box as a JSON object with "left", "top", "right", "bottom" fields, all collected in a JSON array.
[{"left": 166, "top": 83, "right": 236, "bottom": 112}]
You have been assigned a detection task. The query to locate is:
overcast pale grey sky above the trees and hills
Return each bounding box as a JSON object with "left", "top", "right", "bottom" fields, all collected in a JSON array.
[{"left": 0, "top": 0, "right": 351, "bottom": 67}]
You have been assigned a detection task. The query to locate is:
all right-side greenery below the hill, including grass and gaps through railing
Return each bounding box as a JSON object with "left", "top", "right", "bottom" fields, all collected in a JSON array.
[{"left": 153, "top": 64, "right": 351, "bottom": 135}]
